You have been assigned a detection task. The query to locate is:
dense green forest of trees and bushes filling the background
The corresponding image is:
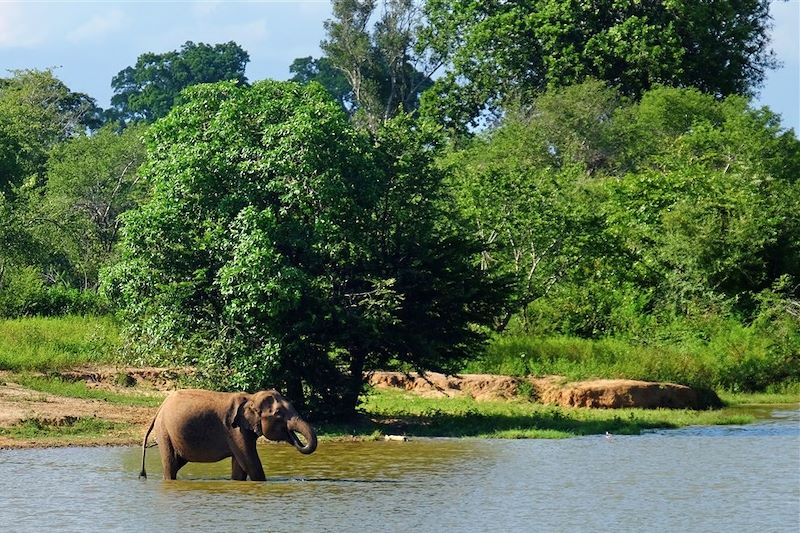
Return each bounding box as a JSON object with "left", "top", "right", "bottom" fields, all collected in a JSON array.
[{"left": 0, "top": 0, "right": 800, "bottom": 415}]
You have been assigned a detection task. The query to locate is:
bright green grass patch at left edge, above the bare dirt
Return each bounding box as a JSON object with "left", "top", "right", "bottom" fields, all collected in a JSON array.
[{"left": 0, "top": 316, "right": 120, "bottom": 372}]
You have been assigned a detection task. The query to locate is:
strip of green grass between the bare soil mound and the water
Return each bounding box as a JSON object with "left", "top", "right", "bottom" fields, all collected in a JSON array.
[{"left": 314, "top": 389, "right": 753, "bottom": 438}]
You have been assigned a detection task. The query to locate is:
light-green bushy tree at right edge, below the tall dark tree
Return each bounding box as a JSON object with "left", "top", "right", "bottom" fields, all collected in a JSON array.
[{"left": 609, "top": 88, "right": 800, "bottom": 316}]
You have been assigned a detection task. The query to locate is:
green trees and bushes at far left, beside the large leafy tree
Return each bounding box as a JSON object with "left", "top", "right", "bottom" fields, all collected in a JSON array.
[{"left": 0, "top": 71, "right": 143, "bottom": 317}]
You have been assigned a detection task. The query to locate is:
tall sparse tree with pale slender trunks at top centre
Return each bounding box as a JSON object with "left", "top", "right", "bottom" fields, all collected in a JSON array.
[{"left": 300, "top": 0, "right": 441, "bottom": 131}]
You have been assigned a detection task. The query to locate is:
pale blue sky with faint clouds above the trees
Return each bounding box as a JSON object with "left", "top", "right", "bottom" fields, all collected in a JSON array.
[{"left": 0, "top": 0, "right": 800, "bottom": 134}]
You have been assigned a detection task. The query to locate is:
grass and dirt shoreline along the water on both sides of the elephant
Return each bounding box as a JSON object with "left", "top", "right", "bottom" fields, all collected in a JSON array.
[{"left": 0, "top": 369, "right": 800, "bottom": 450}]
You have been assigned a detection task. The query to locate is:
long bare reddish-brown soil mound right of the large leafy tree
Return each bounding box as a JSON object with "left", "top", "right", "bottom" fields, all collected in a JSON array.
[{"left": 369, "top": 372, "right": 719, "bottom": 409}]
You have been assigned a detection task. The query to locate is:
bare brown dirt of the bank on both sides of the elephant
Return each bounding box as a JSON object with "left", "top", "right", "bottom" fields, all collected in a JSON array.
[{"left": 0, "top": 367, "right": 719, "bottom": 448}]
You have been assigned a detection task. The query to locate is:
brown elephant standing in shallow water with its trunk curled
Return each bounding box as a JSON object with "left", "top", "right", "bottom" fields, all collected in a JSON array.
[{"left": 139, "top": 389, "right": 317, "bottom": 481}]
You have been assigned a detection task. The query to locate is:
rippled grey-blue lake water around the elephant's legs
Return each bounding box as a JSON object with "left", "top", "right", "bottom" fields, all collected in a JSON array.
[{"left": 0, "top": 408, "right": 800, "bottom": 533}]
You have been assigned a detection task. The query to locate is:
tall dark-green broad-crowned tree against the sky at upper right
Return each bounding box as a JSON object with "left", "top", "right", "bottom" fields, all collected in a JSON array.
[{"left": 421, "top": 0, "right": 776, "bottom": 131}]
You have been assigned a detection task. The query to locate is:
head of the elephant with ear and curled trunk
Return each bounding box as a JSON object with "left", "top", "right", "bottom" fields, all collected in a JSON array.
[{"left": 231, "top": 390, "right": 317, "bottom": 454}]
